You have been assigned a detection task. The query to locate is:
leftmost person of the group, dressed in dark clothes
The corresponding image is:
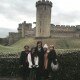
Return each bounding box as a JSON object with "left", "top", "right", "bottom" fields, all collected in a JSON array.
[{"left": 19, "top": 45, "right": 30, "bottom": 80}]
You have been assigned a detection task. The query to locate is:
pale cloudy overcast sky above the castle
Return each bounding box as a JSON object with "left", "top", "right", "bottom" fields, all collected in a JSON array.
[{"left": 0, "top": 0, "right": 80, "bottom": 37}]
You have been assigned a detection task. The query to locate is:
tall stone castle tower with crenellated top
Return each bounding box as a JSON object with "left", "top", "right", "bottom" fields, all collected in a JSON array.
[{"left": 36, "top": 0, "right": 52, "bottom": 37}]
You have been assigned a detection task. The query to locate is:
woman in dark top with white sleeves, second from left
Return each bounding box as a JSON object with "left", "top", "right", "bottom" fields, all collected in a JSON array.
[{"left": 28, "top": 47, "right": 39, "bottom": 80}]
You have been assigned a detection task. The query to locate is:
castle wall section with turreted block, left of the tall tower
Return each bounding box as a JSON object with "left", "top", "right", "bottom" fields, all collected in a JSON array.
[{"left": 9, "top": 21, "right": 35, "bottom": 45}]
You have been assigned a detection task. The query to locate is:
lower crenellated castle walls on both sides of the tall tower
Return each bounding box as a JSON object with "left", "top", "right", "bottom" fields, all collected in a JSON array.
[{"left": 9, "top": 22, "right": 80, "bottom": 45}]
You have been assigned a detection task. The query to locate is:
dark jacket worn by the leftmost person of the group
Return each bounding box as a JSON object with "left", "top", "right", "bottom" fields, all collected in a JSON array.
[{"left": 19, "top": 51, "right": 29, "bottom": 67}]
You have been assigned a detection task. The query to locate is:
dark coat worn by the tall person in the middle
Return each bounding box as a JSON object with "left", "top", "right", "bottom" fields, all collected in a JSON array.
[{"left": 35, "top": 47, "right": 44, "bottom": 69}]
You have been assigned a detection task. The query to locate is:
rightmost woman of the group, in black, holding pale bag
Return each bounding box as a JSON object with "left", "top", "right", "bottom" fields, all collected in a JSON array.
[{"left": 48, "top": 45, "right": 57, "bottom": 80}]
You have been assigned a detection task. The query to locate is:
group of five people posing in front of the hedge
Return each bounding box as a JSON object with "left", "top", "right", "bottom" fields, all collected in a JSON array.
[{"left": 19, "top": 41, "right": 57, "bottom": 80}]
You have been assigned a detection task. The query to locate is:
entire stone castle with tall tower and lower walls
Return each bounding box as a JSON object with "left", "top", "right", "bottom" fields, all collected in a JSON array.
[{"left": 9, "top": 0, "right": 80, "bottom": 44}]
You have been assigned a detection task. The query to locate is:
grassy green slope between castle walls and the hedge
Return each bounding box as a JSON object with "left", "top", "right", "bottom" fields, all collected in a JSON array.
[{"left": 0, "top": 38, "right": 80, "bottom": 53}]
